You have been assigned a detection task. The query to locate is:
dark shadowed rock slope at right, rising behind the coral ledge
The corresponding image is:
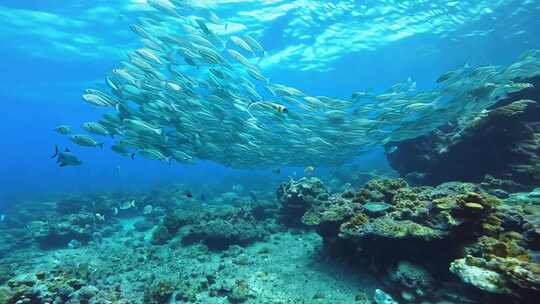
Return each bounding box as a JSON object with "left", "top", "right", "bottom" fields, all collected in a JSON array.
[{"left": 385, "top": 76, "right": 540, "bottom": 188}]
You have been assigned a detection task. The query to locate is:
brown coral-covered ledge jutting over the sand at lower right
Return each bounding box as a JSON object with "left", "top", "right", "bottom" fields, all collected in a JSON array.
[{"left": 280, "top": 179, "right": 540, "bottom": 303}]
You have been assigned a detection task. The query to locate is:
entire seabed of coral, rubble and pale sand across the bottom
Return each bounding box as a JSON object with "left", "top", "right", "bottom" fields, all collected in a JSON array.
[{"left": 0, "top": 178, "right": 540, "bottom": 304}]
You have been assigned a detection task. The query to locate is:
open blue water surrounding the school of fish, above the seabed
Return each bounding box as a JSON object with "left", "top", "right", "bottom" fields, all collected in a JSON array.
[{"left": 0, "top": 1, "right": 540, "bottom": 204}]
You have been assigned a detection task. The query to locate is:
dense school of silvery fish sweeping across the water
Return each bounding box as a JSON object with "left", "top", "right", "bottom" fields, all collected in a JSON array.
[{"left": 56, "top": 0, "right": 540, "bottom": 168}]
